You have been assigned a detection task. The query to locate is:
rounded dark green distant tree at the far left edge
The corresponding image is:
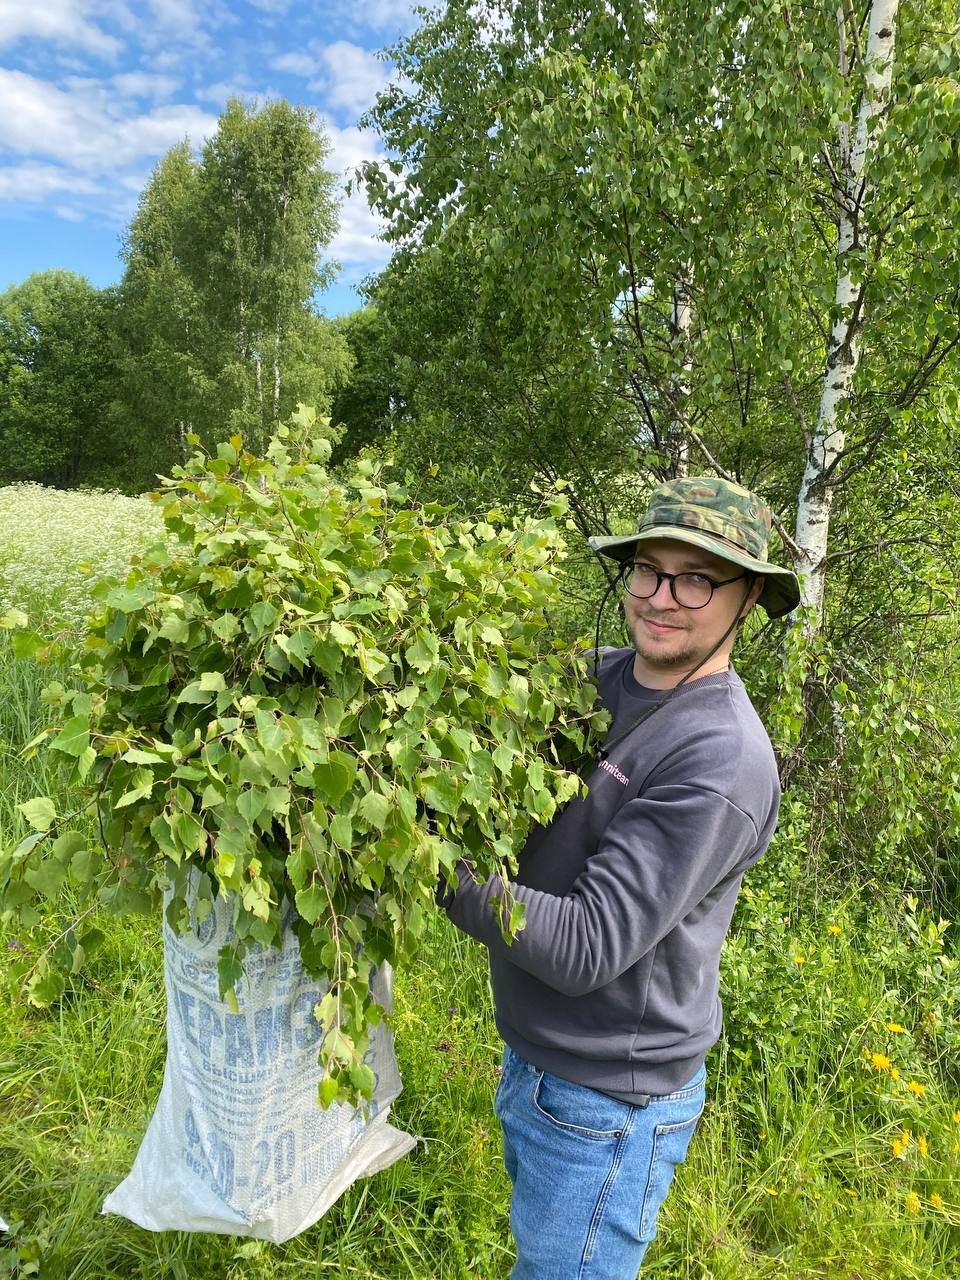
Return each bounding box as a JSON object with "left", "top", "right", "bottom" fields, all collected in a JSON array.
[{"left": 0, "top": 270, "right": 114, "bottom": 488}]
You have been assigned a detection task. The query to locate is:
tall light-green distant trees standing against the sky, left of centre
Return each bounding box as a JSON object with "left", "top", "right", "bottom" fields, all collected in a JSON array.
[{"left": 113, "top": 100, "right": 348, "bottom": 471}]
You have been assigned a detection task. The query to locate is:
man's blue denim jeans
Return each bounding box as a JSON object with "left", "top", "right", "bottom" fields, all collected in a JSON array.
[{"left": 494, "top": 1047, "right": 705, "bottom": 1280}]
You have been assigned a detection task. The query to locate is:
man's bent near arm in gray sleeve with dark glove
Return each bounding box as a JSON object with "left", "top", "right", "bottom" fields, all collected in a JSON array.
[{"left": 447, "top": 782, "right": 759, "bottom": 996}]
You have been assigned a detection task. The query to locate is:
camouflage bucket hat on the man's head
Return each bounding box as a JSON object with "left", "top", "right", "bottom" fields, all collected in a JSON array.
[{"left": 590, "top": 476, "right": 800, "bottom": 618}]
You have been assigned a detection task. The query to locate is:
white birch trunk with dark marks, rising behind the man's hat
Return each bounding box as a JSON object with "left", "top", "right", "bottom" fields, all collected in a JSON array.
[{"left": 796, "top": 0, "right": 899, "bottom": 631}]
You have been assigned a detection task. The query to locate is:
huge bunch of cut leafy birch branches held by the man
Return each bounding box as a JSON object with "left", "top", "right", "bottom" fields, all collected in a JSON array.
[{"left": 0, "top": 411, "right": 603, "bottom": 1102}]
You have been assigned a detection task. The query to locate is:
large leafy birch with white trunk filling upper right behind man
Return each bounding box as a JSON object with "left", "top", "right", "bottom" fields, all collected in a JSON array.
[{"left": 355, "top": 0, "right": 960, "bottom": 881}]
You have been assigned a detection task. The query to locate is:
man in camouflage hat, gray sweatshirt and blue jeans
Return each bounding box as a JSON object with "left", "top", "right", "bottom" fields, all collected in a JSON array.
[{"left": 444, "top": 477, "right": 800, "bottom": 1280}]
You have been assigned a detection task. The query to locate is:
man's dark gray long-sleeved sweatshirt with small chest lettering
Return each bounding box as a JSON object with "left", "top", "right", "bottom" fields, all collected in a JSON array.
[{"left": 447, "top": 649, "right": 780, "bottom": 1094}]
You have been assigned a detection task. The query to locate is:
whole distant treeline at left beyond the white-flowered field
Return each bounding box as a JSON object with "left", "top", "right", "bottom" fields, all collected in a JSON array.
[{"left": 0, "top": 100, "right": 351, "bottom": 493}]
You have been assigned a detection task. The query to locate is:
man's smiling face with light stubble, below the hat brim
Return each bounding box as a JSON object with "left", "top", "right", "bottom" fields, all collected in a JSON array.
[{"left": 623, "top": 538, "right": 763, "bottom": 689}]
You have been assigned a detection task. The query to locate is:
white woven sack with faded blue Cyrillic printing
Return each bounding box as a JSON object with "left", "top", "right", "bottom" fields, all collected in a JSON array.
[{"left": 104, "top": 899, "right": 416, "bottom": 1242}]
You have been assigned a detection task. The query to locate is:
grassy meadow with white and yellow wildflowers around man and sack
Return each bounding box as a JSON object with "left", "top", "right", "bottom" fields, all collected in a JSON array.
[{"left": 0, "top": 486, "right": 960, "bottom": 1280}]
